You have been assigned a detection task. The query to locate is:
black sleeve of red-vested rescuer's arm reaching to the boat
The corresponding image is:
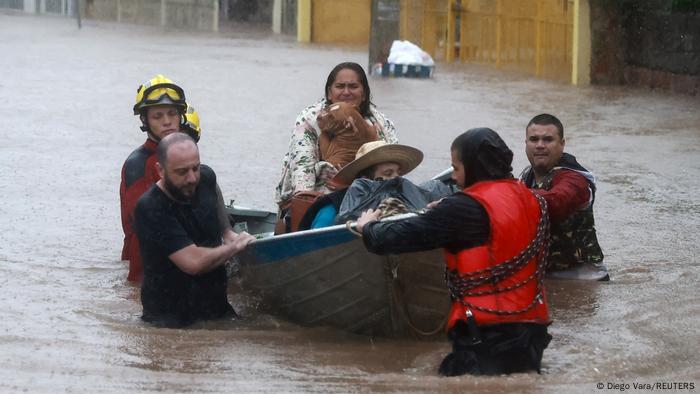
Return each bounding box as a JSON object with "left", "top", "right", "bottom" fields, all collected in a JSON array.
[{"left": 362, "top": 193, "right": 490, "bottom": 254}]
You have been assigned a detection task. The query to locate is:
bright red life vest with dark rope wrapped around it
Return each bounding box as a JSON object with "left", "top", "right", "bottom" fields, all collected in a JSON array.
[{"left": 445, "top": 179, "right": 550, "bottom": 330}]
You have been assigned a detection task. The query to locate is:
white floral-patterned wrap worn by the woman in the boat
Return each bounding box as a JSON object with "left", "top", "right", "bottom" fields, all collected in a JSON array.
[{"left": 275, "top": 99, "right": 398, "bottom": 204}]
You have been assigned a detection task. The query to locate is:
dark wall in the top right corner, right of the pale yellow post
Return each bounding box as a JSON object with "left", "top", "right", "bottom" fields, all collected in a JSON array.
[{"left": 591, "top": 0, "right": 700, "bottom": 95}]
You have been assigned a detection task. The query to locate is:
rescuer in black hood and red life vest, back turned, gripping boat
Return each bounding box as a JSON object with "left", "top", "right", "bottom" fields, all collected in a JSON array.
[{"left": 356, "top": 128, "right": 552, "bottom": 376}]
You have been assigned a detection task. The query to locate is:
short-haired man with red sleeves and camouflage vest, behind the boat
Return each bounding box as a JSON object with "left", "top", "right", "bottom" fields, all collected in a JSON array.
[{"left": 520, "top": 114, "right": 610, "bottom": 281}]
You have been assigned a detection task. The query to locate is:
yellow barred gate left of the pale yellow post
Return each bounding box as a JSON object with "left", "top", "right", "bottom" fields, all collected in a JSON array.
[{"left": 447, "top": 0, "right": 574, "bottom": 81}]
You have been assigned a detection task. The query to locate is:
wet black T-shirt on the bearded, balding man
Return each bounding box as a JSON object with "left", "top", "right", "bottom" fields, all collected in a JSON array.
[{"left": 135, "top": 166, "right": 233, "bottom": 327}]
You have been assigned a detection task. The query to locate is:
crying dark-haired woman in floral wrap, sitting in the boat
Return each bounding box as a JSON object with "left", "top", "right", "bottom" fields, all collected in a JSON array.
[{"left": 275, "top": 62, "right": 398, "bottom": 214}]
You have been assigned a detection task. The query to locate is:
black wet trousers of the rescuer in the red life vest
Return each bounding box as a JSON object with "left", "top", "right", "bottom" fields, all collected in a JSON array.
[{"left": 439, "top": 321, "right": 552, "bottom": 376}]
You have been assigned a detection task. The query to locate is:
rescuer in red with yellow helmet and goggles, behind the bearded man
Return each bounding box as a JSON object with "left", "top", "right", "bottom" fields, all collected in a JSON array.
[{"left": 119, "top": 75, "right": 233, "bottom": 282}]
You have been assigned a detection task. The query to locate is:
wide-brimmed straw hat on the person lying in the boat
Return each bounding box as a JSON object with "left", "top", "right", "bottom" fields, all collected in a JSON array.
[{"left": 333, "top": 141, "right": 423, "bottom": 185}]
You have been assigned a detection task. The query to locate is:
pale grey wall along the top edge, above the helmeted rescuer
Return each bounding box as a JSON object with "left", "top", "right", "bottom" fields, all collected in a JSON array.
[{"left": 84, "top": 0, "right": 219, "bottom": 31}]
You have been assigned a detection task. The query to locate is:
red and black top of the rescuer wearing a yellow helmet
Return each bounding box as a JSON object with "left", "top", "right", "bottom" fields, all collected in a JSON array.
[{"left": 119, "top": 139, "right": 160, "bottom": 282}]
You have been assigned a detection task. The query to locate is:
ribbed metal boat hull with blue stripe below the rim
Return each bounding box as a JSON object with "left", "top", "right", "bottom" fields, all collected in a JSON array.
[{"left": 228, "top": 208, "right": 450, "bottom": 337}]
